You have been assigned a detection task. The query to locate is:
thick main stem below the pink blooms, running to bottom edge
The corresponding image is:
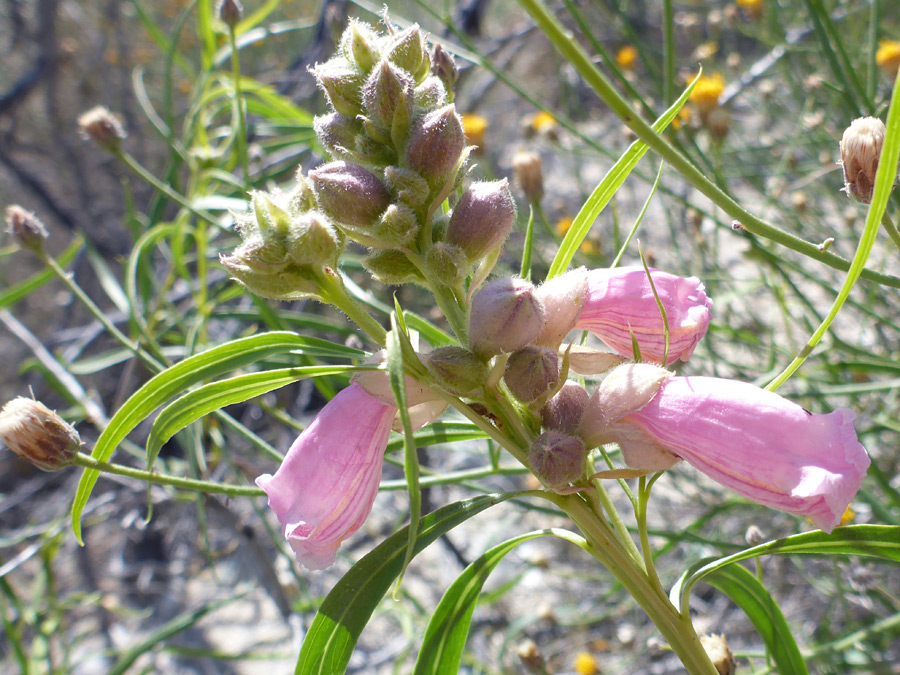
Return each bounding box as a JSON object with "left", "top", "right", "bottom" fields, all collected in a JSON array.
[{"left": 556, "top": 494, "right": 718, "bottom": 675}]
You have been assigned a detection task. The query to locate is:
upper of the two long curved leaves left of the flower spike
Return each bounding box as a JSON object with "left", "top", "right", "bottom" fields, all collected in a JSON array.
[{"left": 72, "top": 332, "right": 342, "bottom": 543}]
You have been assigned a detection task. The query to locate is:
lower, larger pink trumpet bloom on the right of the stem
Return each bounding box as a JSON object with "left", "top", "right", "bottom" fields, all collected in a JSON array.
[{"left": 611, "top": 377, "right": 870, "bottom": 532}]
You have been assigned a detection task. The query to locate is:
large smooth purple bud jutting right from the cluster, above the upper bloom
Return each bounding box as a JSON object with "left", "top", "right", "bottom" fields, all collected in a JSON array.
[{"left": 447, "top": 178, "right": 516, "bottom": 262}]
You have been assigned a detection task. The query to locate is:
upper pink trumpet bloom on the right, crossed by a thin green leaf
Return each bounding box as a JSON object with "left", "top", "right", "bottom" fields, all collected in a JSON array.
[{"left": 575, "top": 266, "right": 712, "bottom": 365}]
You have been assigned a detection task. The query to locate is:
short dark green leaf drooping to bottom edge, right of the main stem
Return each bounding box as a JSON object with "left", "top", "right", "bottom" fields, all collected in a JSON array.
[{"left": 704, "top": 565, "right": 809, "bottom": 675}]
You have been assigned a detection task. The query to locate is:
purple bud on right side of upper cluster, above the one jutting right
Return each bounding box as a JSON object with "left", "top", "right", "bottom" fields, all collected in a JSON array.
[{"left": 406, "top": 105, "right": 466, "bottom": 186}]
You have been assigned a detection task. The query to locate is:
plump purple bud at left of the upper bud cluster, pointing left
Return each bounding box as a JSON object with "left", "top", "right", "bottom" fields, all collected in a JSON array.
[{"left": 309, "top": 161, "right": 391, "bottom": 230}]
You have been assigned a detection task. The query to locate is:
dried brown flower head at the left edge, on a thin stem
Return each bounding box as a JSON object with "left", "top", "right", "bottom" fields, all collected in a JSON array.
[{"left": 0, "top": 396, "right": 81, "bottom": 471}]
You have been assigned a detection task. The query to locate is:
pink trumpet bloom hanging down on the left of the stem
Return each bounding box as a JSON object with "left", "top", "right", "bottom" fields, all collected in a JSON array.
[{"left": 256, "top": 384, "right": 397, "bottom": 570}]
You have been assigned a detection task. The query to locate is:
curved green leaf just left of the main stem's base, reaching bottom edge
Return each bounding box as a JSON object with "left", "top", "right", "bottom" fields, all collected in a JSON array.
[{"left": 413, "top": 528, "right": 587, "bottom": 675}]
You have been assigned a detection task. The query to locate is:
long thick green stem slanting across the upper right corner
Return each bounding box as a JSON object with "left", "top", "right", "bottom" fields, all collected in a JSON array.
[{"left": 518, "top": 0, "right": 900, "bottom": 288}]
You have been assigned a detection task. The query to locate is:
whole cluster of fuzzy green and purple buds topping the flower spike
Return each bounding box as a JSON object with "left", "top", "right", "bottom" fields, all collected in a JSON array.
[{"left": 223, "top": 21, "right": 516, "bottom": 299}]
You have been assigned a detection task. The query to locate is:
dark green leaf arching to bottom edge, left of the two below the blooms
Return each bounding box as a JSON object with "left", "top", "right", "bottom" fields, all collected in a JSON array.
[{"left": 294, "top": 492, "right": 522, "bottom": 675}]
